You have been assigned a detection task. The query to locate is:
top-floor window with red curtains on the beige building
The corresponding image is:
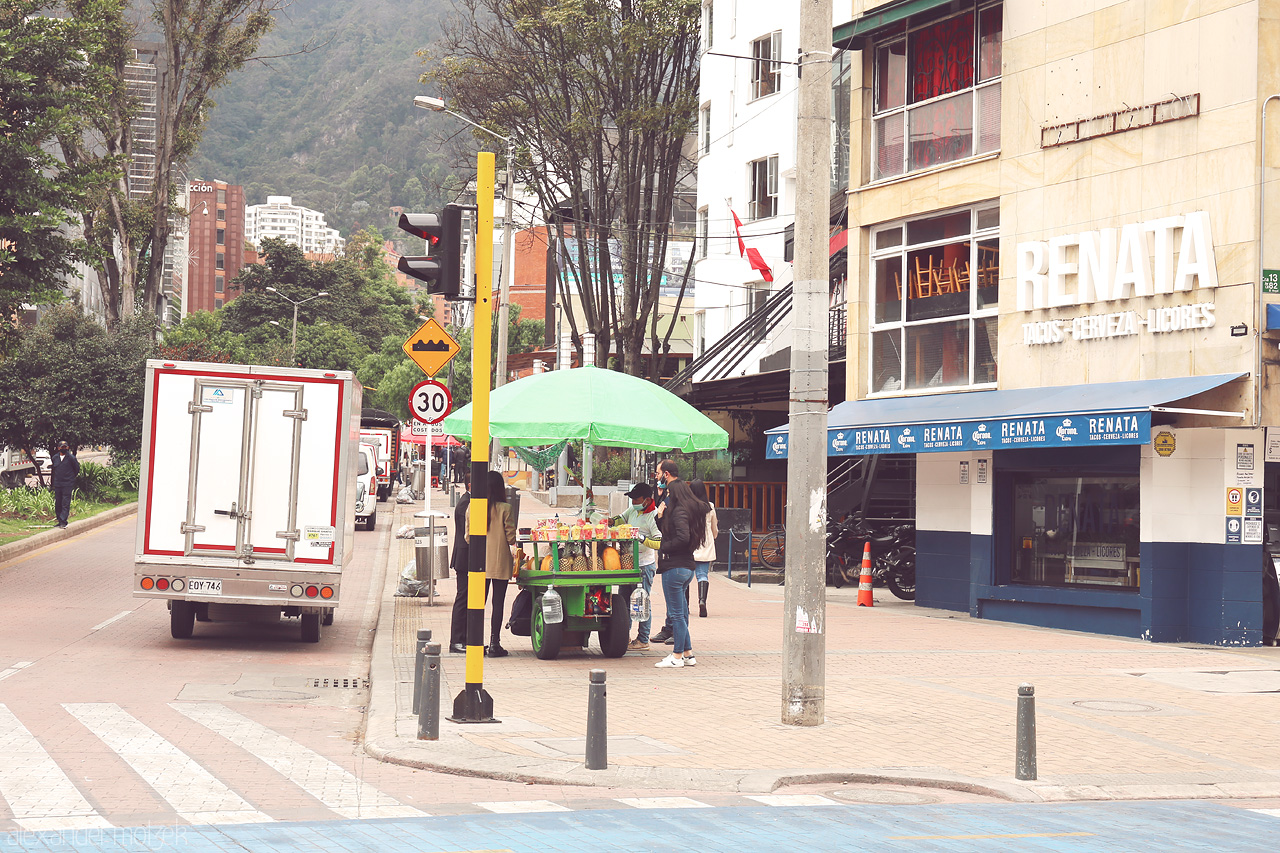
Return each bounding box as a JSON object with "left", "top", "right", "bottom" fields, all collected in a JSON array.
[{"left": 872, "top": 3, "right": 1004, "bottom": 179}]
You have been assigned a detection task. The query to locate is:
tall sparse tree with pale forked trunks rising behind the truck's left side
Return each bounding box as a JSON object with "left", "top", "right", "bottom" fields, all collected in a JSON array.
[{"left": 58, "top": 0, "right": 284, "bottom": 323}]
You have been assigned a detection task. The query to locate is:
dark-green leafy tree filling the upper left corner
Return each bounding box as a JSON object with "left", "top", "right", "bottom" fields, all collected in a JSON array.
[{"left": 0, "top": 0, "right": 120, "bottom": 351}]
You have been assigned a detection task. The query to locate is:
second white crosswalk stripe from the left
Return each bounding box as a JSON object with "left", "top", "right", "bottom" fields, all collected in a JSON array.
[{"left": 63, "top": 702, "right": 271, "bottom": 824}]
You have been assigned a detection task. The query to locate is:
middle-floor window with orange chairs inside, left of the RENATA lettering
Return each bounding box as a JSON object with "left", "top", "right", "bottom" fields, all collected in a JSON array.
[{"left": 870, "top": 204, "right": 1000, "bottom": 393}]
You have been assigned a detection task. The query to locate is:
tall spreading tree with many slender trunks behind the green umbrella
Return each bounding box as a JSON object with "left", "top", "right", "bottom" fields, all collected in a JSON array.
[{"left": 424, "top": 0, "right": 701, "bottom": 375}]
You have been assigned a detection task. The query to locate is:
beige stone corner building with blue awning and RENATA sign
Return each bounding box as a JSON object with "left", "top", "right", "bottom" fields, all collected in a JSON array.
[{"left": 769, "top": 0, "right": 1280, "bottom": 644}]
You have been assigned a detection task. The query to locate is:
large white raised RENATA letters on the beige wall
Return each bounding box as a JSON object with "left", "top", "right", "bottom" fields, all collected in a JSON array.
[{"left": 1016, "top": 210, "right": 1217, "bottom": 311}]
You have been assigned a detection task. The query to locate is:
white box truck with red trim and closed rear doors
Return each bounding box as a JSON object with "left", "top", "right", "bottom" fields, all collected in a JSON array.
[{"left": 133, "top": 360, "right": 362, "bottom": 643}]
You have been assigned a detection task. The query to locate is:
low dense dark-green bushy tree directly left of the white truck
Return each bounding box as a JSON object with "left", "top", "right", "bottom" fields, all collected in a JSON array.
[{"left": 0, "top": 304, "right": 155, "bottom": 473}]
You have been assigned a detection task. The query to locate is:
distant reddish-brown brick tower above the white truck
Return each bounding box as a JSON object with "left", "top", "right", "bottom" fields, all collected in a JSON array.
[{"left": 183, "top": 181, "right": 246, "bottom": 315}]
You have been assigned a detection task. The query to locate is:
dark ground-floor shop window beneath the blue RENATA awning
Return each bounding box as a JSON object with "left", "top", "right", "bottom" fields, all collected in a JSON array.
[{"left": 1010, "top": 471, "right": 1139, "bottom": 589}]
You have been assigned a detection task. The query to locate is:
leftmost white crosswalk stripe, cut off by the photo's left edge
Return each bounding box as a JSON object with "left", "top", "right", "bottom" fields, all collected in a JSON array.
[{"left": 0, "top": 704, "right": 110, "bottom": 831}]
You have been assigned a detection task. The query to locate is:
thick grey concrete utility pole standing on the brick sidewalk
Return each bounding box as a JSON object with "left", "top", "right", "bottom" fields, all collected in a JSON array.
[{"left": 782, "top": 0, "right": 832, "bottom": 726}]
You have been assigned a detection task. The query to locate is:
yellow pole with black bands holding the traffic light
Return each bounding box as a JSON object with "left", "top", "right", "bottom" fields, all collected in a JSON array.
[{"left": 449, "top": 151, "right": 502, "bottom": 722}]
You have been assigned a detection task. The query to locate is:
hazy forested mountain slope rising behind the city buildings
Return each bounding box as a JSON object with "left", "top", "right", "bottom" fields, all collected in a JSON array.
[{"left": 187, "top": 0, "right": 467, "bottom": 237}]
